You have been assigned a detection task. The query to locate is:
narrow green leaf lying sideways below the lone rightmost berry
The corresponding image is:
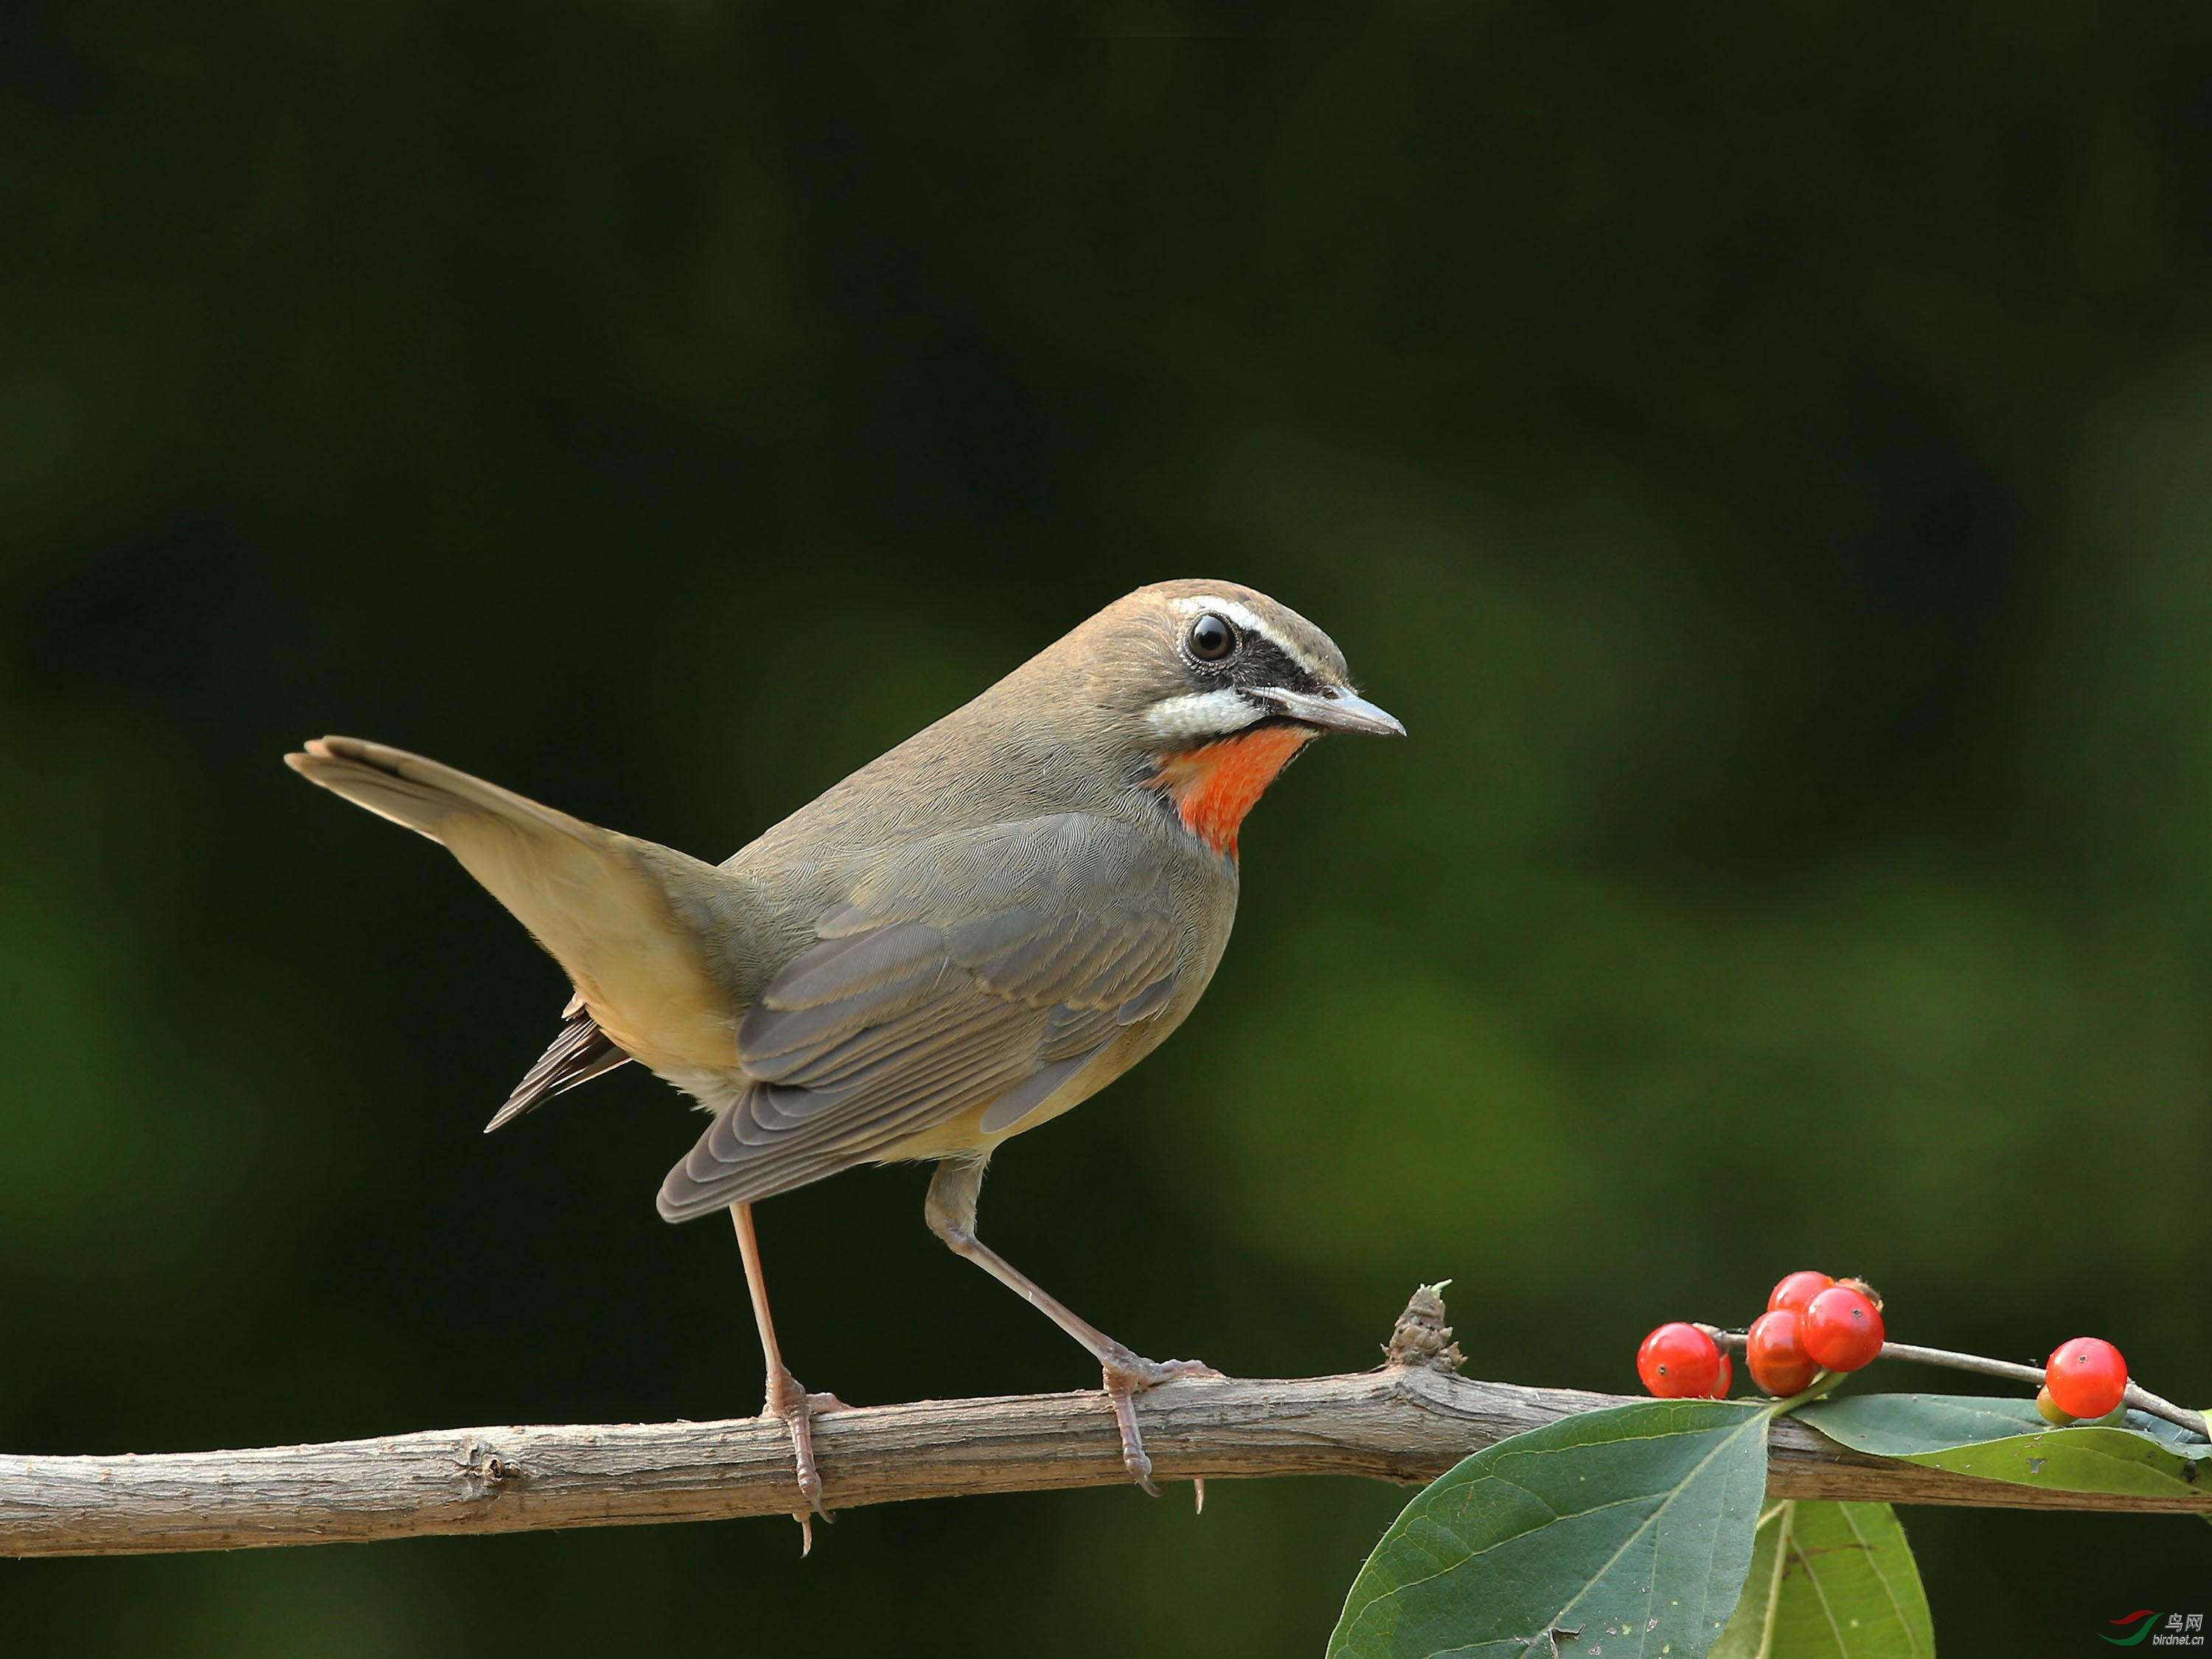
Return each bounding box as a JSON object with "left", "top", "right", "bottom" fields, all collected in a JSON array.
[{"left": 1796, "top": 1394, "right": 2212, "bottom": 1498}]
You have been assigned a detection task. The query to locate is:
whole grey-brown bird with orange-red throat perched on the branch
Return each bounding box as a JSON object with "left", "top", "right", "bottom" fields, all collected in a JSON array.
[{"left": 285, "top": 580, "right": 1405, "bottom": 1548}]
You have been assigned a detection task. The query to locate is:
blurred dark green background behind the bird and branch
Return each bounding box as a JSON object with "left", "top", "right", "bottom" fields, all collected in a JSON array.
[{"left": 0, "top": 0, "right": 2212, "bottom": 1657}]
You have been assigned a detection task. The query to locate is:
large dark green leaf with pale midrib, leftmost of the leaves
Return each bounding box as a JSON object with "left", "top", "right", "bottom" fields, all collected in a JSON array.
[{"left": 1329, "top": 1400, "right": 1770, "bottom": 1659}]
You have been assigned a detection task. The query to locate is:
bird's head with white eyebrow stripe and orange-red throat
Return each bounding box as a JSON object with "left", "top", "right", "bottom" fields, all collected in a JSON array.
[{"left": 1040, "top": 582, "right": 1405, "bottom": 858}]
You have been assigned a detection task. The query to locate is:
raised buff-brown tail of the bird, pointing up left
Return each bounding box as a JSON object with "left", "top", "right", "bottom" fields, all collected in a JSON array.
[{"left": 285, "top": 737, "right": 741, "bottom": 1071}]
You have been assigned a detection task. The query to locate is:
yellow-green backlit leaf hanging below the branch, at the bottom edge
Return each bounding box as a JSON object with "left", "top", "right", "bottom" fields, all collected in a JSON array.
[{"left": 1712, "top": 1502, "right": 1935, "bottom": 1659}]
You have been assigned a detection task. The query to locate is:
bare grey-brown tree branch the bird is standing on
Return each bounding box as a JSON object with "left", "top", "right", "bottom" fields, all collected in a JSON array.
[{"left": 0, "top": 1298, "right": 2212, "bottom": 1555}]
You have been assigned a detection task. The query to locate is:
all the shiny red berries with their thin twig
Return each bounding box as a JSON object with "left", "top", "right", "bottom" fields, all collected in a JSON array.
[{"left": 1637, "top": 1272, "right": 2132, "bottom": 1427}]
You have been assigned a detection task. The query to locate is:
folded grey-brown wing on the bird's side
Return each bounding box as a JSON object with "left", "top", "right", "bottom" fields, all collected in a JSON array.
[{"left": 659, "top": 812, "right": 1179, "bottom": 1221}]
